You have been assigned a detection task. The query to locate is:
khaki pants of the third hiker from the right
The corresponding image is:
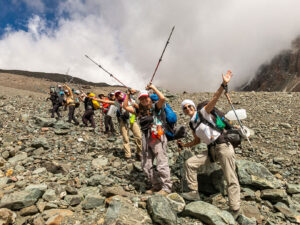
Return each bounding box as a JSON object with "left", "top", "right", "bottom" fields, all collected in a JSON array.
[{"left": 119, "top": 119, "right": 142, "bottom": 158}]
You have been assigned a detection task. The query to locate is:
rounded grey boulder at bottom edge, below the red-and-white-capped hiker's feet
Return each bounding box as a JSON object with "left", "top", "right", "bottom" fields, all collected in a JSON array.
[{"left": 147, "top": 195, "right": 177, "bottom": 225}]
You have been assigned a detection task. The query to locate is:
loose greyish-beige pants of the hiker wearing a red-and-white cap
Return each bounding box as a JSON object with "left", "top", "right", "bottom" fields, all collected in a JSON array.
[{"left": 142, "top": 134, "right": 172, "bottom": 193}]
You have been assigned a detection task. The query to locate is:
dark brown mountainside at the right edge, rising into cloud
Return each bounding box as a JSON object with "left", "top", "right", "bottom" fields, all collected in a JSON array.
[{"left": 241, "top": 37, "right": 300, "bottom": 92}]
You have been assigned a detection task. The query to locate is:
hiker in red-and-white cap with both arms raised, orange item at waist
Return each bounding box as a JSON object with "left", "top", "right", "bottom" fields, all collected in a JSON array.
[{"left": 123, "top": 84, "right": 172, "bottom": 195}]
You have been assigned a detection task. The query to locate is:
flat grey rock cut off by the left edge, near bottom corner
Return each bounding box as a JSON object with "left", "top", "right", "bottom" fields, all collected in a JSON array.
[{"left": 0, "top": 189, "right": 43, "bottom": 210}]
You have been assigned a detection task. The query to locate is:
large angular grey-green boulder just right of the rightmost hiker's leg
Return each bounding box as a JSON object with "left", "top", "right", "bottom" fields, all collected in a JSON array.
[{"left": 236, "top": 160, "right": 281, "bottom": 189}]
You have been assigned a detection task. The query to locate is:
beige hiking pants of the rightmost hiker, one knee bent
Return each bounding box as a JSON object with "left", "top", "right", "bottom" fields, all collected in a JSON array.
[{"left": 185, "top": 143, "right": 240, "bottom": 210}]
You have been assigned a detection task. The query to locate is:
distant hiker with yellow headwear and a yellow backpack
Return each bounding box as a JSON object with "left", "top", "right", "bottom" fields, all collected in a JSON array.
[{"left": 82, "top": 93, "right": 100, "bottom": 129}]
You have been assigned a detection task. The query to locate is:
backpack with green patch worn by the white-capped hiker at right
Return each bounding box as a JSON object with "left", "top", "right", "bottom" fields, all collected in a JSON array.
[{"left": 189, "top": 101, "right": 243, "bottom": 148}]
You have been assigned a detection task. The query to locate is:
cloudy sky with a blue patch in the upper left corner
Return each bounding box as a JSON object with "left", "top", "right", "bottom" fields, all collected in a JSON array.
[{"left": 0, "top": 0, "right": 300, "bottom": 92}]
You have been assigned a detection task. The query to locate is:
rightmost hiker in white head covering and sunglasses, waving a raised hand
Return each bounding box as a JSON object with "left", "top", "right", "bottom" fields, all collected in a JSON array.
[{"left": 177, "top": 70, "right": 240, "bottom": 218}]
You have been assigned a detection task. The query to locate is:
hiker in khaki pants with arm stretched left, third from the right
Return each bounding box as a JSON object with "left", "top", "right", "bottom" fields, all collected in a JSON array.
[{"left": 97, "top": 90, "right": 142, "bottom": 159}]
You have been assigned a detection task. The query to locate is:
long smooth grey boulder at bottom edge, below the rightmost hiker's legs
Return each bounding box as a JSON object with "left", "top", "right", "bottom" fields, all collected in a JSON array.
[{"left": 183, "top": 201, "right": 235, "bottom": 225}]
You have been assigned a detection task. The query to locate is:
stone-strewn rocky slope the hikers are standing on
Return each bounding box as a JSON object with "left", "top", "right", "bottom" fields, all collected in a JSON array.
[{"left": 0, "top": 81, "right": 300, "bottom": 225}]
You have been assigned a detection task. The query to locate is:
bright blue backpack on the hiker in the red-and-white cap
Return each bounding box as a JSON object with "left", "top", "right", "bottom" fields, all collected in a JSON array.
[{"left": 150, "top": 94, "right": 186, "bottom": 141}]
